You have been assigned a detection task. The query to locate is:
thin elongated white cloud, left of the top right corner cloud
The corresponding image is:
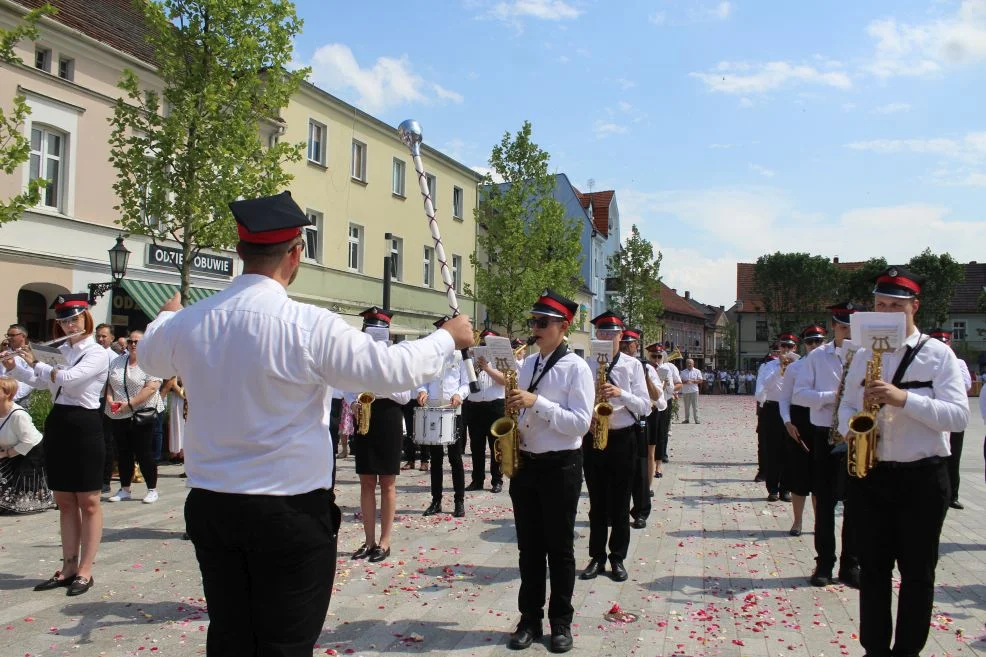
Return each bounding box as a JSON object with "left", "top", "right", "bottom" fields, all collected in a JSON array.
[{"left": 689, "top": 62, "right": 852, "bottom": 95}]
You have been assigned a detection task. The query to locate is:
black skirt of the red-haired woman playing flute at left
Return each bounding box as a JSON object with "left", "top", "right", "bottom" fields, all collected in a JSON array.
[{"left": 43, "top": 404, "right": 106, "bottom": 493}]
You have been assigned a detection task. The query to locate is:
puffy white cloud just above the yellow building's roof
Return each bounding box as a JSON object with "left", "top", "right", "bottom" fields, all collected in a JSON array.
[{"left": 308, "top": 43, "right": 463, "bottom": 113}]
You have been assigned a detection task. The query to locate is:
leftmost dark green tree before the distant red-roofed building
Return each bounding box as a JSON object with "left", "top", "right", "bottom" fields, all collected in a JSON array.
[{"left": 753, "top": 252, "right": 839, "bottom": 337}]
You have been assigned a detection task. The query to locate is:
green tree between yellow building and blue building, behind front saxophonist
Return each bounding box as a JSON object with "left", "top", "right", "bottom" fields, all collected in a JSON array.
[{"left": 466, "top": 121, "right": 582, "bottom": 335}]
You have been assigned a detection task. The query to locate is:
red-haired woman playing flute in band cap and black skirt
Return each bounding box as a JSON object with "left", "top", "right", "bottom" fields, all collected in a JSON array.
[{"left": 3, "top": 293, "right": 107, "bottom": 595}]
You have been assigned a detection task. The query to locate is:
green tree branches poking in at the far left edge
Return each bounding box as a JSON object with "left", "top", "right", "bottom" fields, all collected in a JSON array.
[{"left": 0, "top": 3, "right": 56, "bottom": 226}]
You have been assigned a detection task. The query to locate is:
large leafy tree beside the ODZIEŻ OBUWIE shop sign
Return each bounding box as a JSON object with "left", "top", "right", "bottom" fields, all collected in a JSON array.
[{"left": 110, "top": 0, "right": 308, "bottom": 303}]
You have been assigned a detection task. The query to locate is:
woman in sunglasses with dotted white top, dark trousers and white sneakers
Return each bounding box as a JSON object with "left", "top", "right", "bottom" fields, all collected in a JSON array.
[{"left": 106, "top": 331, "right": 164, "bottom": 504}]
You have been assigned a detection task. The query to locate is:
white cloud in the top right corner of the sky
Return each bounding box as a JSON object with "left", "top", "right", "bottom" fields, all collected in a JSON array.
[{"left": 863, "top": 0, "right": 986, "bottom": 78}]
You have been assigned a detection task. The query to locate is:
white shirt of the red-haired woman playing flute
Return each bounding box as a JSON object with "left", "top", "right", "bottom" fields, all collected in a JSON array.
[{"left": 8, "top": 335, "right": 108, "bottom": 409}]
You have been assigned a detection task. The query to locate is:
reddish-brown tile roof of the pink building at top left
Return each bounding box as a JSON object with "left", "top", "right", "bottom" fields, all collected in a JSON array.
[{"left": 14, "top": 0, "right": 154, "bottom": 65}]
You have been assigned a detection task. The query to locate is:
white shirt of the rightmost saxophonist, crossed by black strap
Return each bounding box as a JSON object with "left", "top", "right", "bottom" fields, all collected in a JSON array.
[{"left": 839, "top": 330, "right": 969, "bottom": 462}]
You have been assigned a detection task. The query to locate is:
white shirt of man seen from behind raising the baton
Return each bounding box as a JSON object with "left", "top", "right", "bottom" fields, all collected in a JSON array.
[{"left": 137, "top": 274, "right": 454, "bottom": 495}]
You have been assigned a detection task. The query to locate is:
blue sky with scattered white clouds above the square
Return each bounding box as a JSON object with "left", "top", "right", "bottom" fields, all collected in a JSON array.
[{"left": 295, "top": 0, "right": 986, "bottom": 306}]
